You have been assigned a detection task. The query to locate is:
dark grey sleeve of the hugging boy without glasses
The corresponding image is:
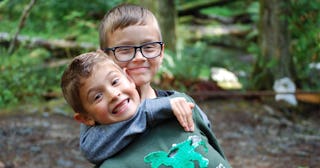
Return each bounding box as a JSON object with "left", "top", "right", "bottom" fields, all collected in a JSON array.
[{"left": 80, "top": 97, "right": 174, "bottom": 164}]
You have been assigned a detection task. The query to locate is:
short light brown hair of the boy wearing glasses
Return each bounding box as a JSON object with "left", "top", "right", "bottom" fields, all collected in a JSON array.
[{"left": 99, "top": 4, "right": 162, "bottom": 50}]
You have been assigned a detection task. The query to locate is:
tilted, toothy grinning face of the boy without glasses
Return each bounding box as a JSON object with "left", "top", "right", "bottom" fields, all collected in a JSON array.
[{"left": 75, "top": 62, "right": 140, "bottom": 125}]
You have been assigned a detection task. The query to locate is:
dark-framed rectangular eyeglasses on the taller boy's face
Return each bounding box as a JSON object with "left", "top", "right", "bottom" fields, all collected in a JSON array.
[{"left": 104, "top": 41, "right": 163, "bottom": 62}]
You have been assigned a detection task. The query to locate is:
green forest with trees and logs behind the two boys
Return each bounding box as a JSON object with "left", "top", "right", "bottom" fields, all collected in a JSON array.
[{"left": 0, "top": 0, "right": 320, "bottom": 108}]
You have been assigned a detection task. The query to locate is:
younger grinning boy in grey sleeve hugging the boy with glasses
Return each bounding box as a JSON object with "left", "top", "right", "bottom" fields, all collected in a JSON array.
[{"left": 61, "top": 52, "right": 194, "bottom": 164}]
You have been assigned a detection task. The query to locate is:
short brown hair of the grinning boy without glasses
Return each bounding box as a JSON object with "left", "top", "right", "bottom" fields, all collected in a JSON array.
[{"left": 60, "top": 51, "right": 121, "bottom": 113}]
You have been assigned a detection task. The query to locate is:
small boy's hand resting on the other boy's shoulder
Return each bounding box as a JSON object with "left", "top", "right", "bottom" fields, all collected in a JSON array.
[{"left": 170, "top": 97, "right": 194, "bottom": 131}]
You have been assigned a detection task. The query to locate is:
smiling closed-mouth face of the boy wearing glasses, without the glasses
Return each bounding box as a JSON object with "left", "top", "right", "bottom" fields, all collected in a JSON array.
[{"left": 107, "top": 19, "right": 164, "bottom": 87}]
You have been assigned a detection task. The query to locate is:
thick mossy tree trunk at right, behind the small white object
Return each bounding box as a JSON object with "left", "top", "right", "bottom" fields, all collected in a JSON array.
[{"left": 252, "top": 0, "right": 294, "bottom": 90}]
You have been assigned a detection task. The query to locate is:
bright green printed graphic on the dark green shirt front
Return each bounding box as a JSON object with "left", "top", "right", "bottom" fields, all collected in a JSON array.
[{"left": 144, "top": 135, "right": 209, "bottom": 168}]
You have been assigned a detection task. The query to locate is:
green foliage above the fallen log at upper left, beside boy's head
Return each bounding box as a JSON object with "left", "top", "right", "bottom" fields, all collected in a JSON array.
[{"left": 0, "top": 0, "right": 123, "bottom": 44}]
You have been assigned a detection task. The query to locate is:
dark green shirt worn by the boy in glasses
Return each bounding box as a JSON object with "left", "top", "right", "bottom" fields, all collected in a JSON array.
[{"left": 99, "top": 92, "right": 231, "bottom": 168}]
